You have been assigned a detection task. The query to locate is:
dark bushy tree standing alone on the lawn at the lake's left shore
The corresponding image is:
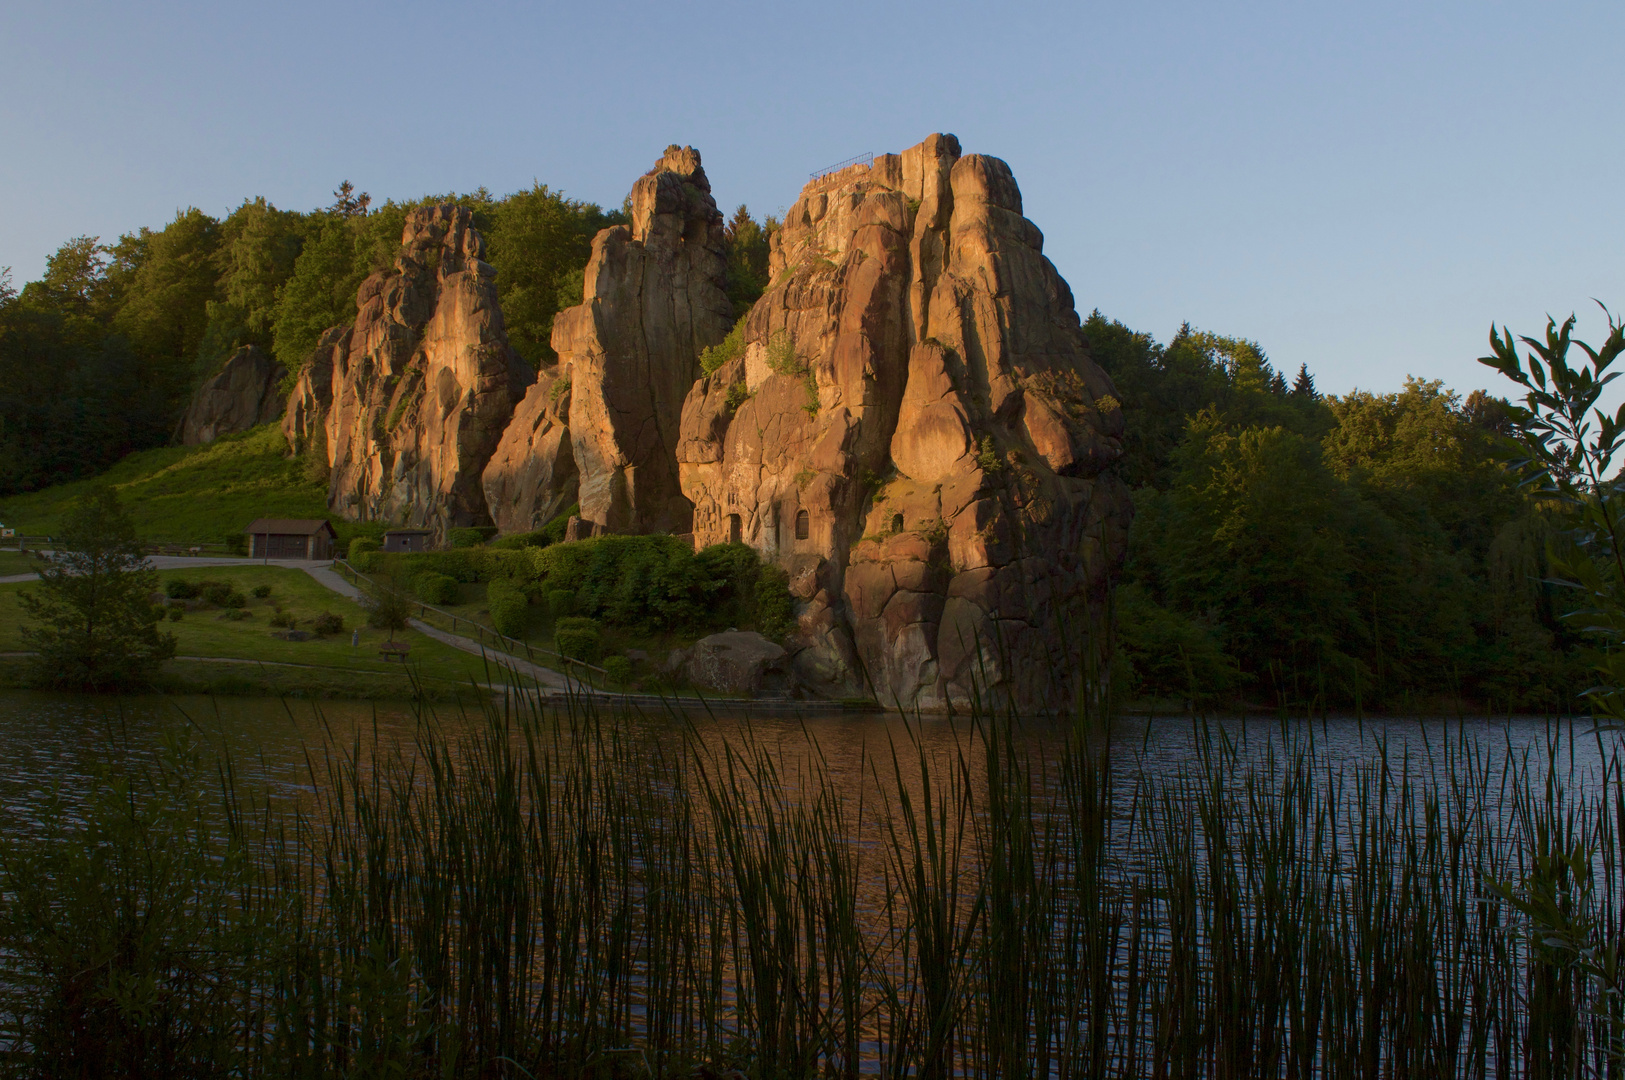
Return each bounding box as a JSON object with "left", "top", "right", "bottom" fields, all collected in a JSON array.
[{"left": 20, "top": 487, "right": 176, "bottom": 690}]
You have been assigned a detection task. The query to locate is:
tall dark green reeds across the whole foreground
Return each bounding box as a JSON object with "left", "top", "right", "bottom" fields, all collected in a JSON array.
[{"left": 0, "top": 678, "right": 1625, "bottom": 1080}]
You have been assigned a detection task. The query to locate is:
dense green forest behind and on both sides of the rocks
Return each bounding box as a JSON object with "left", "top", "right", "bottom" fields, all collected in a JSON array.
[{"left": 0, "top": 182, "right": 1591, "bottom": 710}]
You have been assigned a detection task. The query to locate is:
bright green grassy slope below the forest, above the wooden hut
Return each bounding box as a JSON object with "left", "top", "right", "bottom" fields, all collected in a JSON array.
[{"left": 0, "top": 424, "right": 352, "bottom": 544}]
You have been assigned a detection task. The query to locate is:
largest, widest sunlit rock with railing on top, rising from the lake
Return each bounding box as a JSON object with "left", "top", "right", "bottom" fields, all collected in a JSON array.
[{"left": 672, "top": 135, "right": 1133, "bottom": 708}]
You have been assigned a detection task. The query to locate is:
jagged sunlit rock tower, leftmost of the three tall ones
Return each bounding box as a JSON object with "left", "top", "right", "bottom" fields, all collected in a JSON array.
[{"left": 284, "top": 205, "right": 531, "bottom": 539}]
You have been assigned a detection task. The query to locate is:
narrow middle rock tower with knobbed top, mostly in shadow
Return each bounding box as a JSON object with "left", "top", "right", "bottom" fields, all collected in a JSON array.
[{"left": 553, "top": 146, "right": 733, "bottom": 533}]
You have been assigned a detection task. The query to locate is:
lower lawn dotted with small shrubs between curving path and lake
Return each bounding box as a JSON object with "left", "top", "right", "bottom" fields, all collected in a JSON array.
[{"left": 0, "top": 565, "right": 552, "bottom": 697}]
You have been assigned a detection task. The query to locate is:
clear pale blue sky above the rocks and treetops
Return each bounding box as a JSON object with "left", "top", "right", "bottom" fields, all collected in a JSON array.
[{"left": 0, "top": 0, "right": 1625, "bottom": 391}]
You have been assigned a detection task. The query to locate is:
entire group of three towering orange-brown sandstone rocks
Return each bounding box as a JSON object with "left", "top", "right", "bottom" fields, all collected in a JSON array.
[{"left": 269, "top": 135, "right": 1131, "bottom": 708}]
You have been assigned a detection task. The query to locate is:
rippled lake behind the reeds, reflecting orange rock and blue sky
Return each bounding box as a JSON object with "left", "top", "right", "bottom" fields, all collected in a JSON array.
[{"left": 0, "top": 693, "right": 1625, "bottom": 1077}]
